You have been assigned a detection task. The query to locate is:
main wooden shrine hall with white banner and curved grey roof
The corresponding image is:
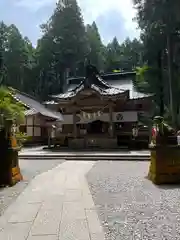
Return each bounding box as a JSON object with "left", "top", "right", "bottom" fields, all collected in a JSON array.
[{"left": 44, "top": 72, "right": 152, "bottom": 149}]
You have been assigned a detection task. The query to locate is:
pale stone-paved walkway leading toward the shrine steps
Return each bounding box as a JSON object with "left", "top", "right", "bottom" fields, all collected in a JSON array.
[{"left": 0, "top": 161, "right": 105, "bottom": 240}]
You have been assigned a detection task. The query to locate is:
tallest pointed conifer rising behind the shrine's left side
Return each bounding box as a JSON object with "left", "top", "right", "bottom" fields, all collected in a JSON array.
[{"left": 35, "top": 0, "right": 87, "bottom": 99}]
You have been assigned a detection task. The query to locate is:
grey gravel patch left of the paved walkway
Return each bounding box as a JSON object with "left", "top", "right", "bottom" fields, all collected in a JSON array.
[{"left": 0, "top": 159, "right": 64, "bottom": 215}]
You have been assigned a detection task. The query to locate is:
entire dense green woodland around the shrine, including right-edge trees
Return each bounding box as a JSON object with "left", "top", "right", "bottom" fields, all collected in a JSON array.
[{"left": 0, "top": 0, "right": 180, "bottom": 125}]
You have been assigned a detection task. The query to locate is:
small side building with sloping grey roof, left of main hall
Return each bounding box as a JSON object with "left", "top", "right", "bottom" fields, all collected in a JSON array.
[{"left": 12, "top": 89, "right": 63, "bottom": 144}]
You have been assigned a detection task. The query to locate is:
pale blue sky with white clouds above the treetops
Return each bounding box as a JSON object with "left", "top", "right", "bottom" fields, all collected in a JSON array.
[{"left": 0, "top": 0, "right": 139, "bottom": 45}]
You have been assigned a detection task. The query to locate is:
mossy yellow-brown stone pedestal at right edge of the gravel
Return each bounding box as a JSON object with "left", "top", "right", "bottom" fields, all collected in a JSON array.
[{"left": 148, "top": 145, "right": 180, "bottom": 184}]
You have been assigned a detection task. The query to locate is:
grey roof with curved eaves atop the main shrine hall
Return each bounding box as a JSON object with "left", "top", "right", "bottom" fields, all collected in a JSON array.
[{"left": 46, "top": 72, "right": 152, "bottom": 104}]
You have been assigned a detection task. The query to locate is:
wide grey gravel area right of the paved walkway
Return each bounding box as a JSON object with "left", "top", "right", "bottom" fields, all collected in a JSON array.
[{"left": 87, "top": 161, "right": 180, "bottom": 240}]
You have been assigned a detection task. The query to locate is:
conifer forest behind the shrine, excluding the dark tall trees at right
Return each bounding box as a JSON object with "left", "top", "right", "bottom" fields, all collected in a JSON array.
[{"left": 0, "top": 0, "right": 142, "bottom": 100}]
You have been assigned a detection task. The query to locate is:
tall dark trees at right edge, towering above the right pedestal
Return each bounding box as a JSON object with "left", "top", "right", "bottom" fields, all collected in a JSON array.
[{"left": 133, "top": 0, "right": 180, "bottom": 127}]
